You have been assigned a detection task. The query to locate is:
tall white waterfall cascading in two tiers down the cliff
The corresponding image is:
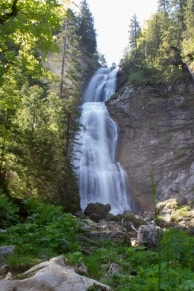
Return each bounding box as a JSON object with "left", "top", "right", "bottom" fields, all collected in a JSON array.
[{"left": 75, "top": 68, "right": 131, "bottom": 214}]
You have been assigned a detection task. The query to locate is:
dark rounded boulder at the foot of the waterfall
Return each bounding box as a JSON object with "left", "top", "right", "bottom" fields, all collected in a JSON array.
[{"left": 84, "top": 203, "right": 111, "bottom": 222}]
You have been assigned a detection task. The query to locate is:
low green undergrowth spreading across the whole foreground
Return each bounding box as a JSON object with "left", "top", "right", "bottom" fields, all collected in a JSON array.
[{"left": 0, "top": 194, "right": 194, "bottom": 291}]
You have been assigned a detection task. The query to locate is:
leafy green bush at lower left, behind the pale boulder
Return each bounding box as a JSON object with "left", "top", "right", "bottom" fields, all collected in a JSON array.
[{"left": 2, "top": 200, "right": 79, "bottom": 254}]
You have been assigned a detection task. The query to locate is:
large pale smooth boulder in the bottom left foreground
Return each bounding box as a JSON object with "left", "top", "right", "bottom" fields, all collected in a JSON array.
[{"left": 0, "top": 256, "right": 111, "bottom": 291}]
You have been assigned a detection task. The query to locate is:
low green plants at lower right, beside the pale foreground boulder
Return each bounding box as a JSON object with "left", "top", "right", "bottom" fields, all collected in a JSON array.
[{"left": 69, "top": 229, "right": 194, "bottom": 291}]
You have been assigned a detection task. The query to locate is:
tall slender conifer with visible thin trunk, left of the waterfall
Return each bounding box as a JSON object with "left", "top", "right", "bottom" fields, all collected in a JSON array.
[{"left": 56, "top": 9, "right": 82, "bottom": 157}]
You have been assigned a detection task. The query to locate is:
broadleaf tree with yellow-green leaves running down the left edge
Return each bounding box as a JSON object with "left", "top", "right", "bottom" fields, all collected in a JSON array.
[{"left": 0, "top": 0, "right": 65, "bottom": 196}]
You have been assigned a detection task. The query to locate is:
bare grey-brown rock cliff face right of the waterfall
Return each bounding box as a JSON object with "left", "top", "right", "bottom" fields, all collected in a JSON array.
[{"left": 107, "top": 84, "right": 194, "bottom": 210}]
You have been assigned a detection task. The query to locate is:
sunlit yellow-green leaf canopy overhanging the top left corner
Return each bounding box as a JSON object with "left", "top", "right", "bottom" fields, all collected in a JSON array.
[{"left": 0, "top": 0, "right": 65, "bottom": 78}]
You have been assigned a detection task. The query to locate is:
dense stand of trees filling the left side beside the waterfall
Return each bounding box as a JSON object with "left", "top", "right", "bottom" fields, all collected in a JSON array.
[{"left": 0, "top": 0, "right": 98, "bottom": 211}]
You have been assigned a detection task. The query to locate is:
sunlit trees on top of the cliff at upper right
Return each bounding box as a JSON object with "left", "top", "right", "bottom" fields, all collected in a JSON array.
[{"left": 120, "top": 0, "right": 194, "bottom": 85}]
